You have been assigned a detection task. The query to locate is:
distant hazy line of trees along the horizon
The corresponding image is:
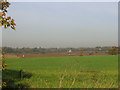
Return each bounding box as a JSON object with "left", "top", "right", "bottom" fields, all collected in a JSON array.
[{"left": 2, "top": 46, "right": 118, "bottom": 55}]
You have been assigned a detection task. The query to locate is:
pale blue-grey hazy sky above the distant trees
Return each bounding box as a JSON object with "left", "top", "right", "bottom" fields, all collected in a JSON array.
[{"left": 2, "top": 2, "right": 118, "bottom": 48}]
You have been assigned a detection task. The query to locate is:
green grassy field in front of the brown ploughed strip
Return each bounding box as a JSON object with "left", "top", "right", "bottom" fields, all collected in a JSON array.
[{"left": 3, "top": 55, "right": 118, "bottom": 88}]
